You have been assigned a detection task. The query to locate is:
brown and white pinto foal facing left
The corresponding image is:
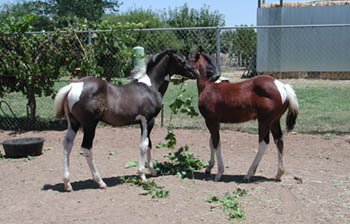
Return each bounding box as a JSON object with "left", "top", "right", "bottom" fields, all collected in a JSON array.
[{"left": 190, "top": 49, "right": 298, "bottom": 181}]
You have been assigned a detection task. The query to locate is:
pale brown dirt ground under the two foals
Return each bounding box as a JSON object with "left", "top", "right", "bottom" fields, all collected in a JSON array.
[{"left": 0, "top": 127, "right": 350, "bottom": 224}]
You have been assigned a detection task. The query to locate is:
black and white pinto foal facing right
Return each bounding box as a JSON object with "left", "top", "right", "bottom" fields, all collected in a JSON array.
[{"left": 55, "top": 49, "right": 199, "bottom": 191}]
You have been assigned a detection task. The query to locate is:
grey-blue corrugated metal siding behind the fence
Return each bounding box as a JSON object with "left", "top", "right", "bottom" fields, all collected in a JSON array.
[{"left": 257, "top": 6, "right": 350, "bottom": 72}]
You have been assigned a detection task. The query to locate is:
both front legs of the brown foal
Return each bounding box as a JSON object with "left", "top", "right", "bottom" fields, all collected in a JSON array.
[{"left": 205, "top": 120, "right": 224, "bottom": 181}]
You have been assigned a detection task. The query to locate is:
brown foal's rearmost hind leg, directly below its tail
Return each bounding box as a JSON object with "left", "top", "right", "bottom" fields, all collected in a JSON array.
[{"left": 271, "top": 121, "right": 284, "bottom": 181}]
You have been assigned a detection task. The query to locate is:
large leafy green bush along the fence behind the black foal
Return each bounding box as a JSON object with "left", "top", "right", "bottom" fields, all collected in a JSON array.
[{"left": 0, "top": 14, "right": 136, "bottom": 120}]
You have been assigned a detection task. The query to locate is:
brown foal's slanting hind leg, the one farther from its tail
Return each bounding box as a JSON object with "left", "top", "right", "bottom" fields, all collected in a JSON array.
[{"left": 243, "top": 122, "right": 270, "bottom": 182}]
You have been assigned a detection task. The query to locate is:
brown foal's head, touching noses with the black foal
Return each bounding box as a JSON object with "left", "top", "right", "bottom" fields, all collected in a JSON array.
[{"left": 189, "top": 47, "right": 220, "bottom": 81}]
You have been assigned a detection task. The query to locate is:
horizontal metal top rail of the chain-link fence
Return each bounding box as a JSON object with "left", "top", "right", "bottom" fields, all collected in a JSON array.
[{"left": 6, "top": 24, "right": 350, "bottom": 34}]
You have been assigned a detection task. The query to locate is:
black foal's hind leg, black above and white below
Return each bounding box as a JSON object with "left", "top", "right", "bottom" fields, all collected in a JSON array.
[{"left": 81, "top": 122, "right": 107, "bottom": 189}]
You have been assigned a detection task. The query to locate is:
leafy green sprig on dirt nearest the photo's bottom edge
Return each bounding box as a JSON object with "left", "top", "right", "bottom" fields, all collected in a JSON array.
[{"left": 204, "top": 188, "right": 247, "bottom": 220}]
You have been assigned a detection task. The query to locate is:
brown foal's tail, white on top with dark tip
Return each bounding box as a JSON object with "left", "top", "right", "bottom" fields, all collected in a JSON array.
[{"left": 284, "top": 84, "right": 299, "bottom": 132}]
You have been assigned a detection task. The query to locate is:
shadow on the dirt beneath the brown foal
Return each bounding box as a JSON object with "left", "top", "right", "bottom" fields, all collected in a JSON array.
[{"left": 193, "top": 172, "right": 275, "bottom": 184}]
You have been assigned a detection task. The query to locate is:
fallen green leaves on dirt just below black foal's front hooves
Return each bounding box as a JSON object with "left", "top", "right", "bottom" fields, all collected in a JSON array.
[{"left": 121, "top": 177, "right": 169, "bottom": 198}]
